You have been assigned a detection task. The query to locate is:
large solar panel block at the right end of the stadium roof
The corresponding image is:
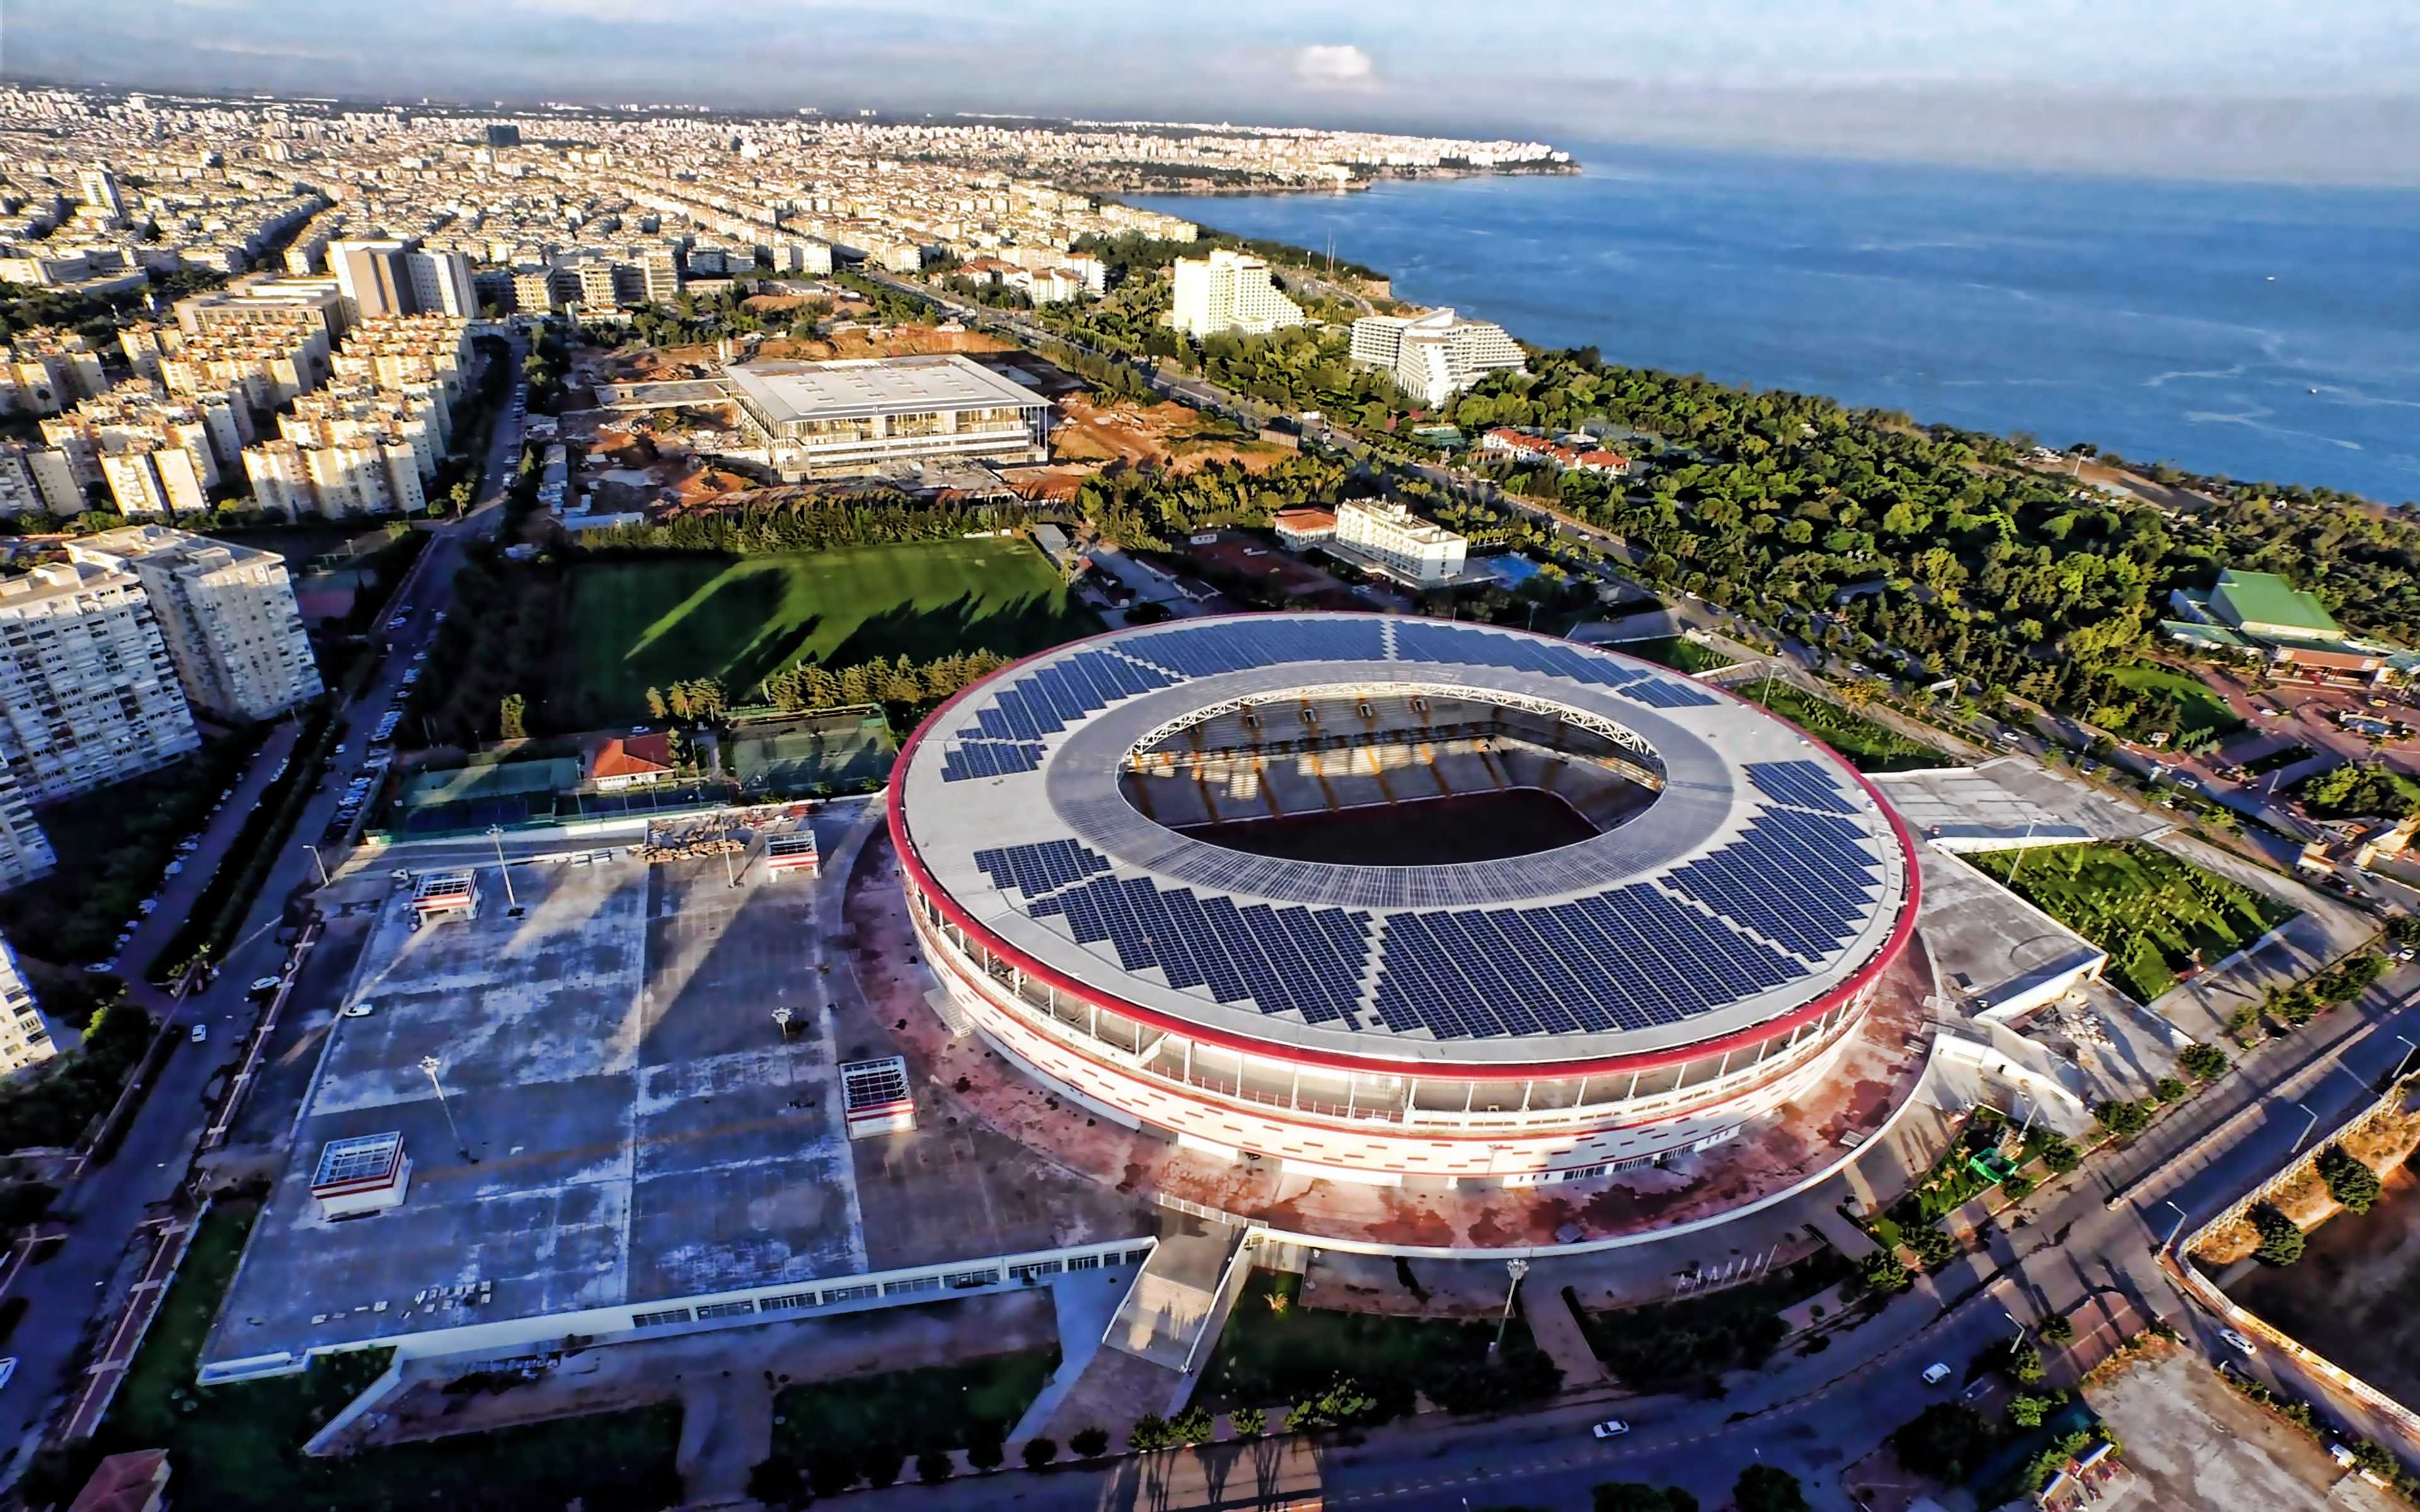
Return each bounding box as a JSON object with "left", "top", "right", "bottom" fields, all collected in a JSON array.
[{"left": 1665, "top": 808, "right": 1883, "bottom": 960}]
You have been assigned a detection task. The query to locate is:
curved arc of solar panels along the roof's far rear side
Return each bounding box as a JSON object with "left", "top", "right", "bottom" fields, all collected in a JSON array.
[{"left": 942, "top": 614, "right": 1716, "bottom": 781}]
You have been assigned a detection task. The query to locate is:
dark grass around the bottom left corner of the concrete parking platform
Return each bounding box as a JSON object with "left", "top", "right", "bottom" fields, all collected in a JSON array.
[{"left": 59, "top": 1202, "right": 680, "bottom": 1512}]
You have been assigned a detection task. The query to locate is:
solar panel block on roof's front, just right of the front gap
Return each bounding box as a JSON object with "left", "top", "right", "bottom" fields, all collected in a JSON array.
[{"left": 1377, "top": 883, "right": 1807, "bottom": 1040}]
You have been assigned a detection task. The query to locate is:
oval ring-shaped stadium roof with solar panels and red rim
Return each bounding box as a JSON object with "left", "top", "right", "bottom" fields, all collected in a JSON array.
[{"left": 890, "top": 614, "right": 1916, "bottom": 1074}]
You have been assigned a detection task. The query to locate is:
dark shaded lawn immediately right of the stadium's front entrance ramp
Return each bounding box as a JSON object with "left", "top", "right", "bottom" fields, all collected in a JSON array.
[{"left": 1193, "top": 1270, "right": 1536, "bottom": 1411}]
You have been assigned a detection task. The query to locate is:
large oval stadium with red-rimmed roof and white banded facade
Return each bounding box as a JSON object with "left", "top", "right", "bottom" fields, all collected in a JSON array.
[{"left": 888, "top": 614, "right": 1916, "bottom": 1186}]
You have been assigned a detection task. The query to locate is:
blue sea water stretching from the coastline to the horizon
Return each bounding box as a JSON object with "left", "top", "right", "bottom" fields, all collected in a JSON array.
[{"left": 1135, "top": 147, "right": 2420, "bottom": 501}]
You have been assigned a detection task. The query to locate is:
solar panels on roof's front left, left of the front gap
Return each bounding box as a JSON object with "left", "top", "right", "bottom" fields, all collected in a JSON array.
[{"left": 976, "top": 839, "right": 1369, "bottom": 1023}]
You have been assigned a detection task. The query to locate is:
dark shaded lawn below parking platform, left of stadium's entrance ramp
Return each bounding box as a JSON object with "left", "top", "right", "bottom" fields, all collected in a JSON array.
[{"left": 772, "top": 1350, "right": 1057, "bottom": 1461}]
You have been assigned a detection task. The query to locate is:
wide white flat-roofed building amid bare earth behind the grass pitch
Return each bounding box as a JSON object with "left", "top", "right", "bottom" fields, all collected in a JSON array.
[{"left": 723, "top": 353, "right": 1051, "bottom": 479}]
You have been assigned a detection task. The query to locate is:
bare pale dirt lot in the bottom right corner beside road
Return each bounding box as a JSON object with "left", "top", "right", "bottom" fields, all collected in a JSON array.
[{"left": 2083, "top": 1350, "right": 2396, "bottom": 1512}]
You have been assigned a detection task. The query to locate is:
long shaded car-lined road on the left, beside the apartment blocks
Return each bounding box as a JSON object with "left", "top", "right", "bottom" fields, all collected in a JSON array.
[{"left": 0, "top": 341, "right": 525, "bottom": 1486}]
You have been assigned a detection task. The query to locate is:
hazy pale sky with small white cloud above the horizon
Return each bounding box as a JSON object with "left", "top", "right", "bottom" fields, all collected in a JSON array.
[{"left": 14, "top": 0, "right": 2420, "bottom": 181}]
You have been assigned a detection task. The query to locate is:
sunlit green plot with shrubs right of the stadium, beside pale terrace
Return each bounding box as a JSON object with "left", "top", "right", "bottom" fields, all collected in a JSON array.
[{"left": 1970, "top": 842, "right": 2294, "bottom": 1002}]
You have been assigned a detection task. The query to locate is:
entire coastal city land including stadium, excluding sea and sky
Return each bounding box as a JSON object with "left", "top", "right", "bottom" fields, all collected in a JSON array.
[{"left": 0, "top": 84, "right": 2420, "bottom": 1512}]
